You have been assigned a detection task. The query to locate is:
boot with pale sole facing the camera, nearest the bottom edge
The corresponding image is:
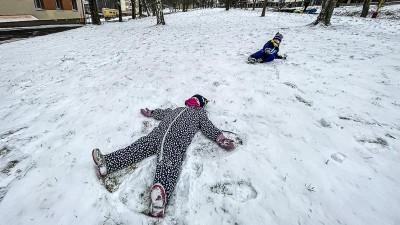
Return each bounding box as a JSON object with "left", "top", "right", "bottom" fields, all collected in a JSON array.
[{"left": 150, "top": 183, "right": 166, "bottom": 217}]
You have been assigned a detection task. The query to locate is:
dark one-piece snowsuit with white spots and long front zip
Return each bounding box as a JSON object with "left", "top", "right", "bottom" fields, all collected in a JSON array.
[{"left": 104, "top": 107, "right": 222, "bottom": 202}]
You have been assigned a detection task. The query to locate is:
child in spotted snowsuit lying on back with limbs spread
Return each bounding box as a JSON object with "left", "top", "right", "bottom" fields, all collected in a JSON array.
[{"left": 92, "top": 95, "right": 235, "bottom": 217}]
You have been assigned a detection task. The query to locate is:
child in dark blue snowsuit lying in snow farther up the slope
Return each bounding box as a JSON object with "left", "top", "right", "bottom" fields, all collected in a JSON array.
[{"left": 247, "top": 32, "right": 286, "bottom": 63}]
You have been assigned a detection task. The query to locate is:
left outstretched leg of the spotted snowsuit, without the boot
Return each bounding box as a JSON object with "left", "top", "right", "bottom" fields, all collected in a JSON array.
[{"left": 104, "top": 135, "right": 159, "bottom": 173}]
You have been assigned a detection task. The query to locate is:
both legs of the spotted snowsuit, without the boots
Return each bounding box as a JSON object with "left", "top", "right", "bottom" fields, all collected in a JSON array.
[{"left": 104, "top": 134, "right": 186, "bottom": 203}]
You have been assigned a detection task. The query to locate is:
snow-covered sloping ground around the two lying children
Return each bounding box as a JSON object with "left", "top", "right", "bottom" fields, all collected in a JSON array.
[{"left": 0, "top": 6, "right": 400, "bottom": 225}]
